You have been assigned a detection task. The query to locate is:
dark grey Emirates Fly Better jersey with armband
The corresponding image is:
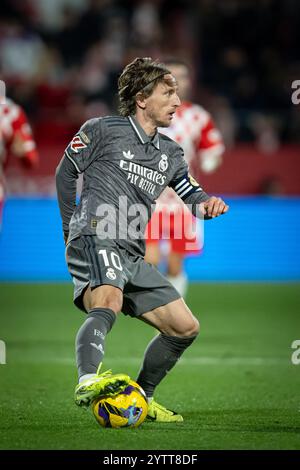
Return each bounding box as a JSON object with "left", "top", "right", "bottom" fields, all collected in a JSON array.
[{"left": 56, "top": 116, "right": 209, "bottom": 255}]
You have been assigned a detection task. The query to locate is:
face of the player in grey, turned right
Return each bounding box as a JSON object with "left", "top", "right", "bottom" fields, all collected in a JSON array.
[{"left": 145, "top": 74, "right": 180, "bottom": 127}]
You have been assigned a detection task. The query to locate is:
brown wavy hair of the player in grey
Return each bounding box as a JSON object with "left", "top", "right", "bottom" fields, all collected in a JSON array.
[{"left": 118, "top": 57, "right": 170, "bottom": 116}]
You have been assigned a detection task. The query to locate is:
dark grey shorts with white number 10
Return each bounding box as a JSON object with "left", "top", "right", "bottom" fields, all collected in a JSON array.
[{"left": 66, "top": 235, "right": 180, "bottom": 317}]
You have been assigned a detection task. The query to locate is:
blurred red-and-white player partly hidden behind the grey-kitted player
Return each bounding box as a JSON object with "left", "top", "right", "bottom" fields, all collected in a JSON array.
[{"left": 145, "top": 59, "right": 224, "bottom": 297}]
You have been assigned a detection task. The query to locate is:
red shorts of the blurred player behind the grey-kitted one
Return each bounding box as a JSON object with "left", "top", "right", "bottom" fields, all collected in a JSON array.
[{"left": 145, "top": 208, "right": 202, "bottom": 254}]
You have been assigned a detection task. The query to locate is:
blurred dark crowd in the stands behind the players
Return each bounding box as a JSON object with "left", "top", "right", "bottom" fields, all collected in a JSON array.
[{"left": 0, "top": 0, "right": 300, "bottom": 193}]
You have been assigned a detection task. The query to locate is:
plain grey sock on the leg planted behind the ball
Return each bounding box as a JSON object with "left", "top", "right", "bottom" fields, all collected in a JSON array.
[{"left": 137, "top": 334, "right": 196, "bottom": 397}]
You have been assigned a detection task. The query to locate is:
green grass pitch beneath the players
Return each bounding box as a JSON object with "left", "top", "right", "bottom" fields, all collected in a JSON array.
[{"left": 0, "top": 283, "right": 300, "bottom": 450}]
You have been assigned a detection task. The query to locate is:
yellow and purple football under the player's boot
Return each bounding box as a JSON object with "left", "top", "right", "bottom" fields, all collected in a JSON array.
[{"left": 92, "top": 380, "right": 148, "bottom": 428}]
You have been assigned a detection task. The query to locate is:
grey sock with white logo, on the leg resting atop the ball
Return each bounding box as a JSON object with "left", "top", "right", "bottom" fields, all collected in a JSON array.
[{"left": 76, "top": 308, "right": 116, "bottom": 378}]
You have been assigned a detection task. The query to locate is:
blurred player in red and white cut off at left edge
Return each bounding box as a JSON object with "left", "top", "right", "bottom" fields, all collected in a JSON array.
[{"left": 0, "top": 98, "right": 38, "bottom": 227}]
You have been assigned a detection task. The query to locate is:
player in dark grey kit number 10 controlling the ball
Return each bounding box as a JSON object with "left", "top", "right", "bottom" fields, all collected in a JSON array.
[{"left": 56, "top": 58, "right": 228, "bottom": 422}]
